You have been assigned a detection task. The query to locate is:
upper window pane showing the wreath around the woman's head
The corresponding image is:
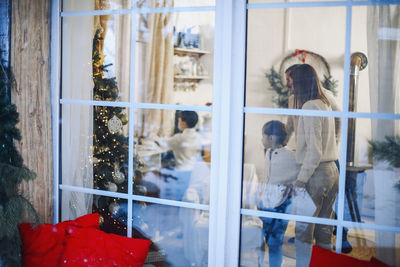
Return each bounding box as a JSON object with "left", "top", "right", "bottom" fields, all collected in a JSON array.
[{"left": 246, "top": 7, "right": 346, "bottom": 108}]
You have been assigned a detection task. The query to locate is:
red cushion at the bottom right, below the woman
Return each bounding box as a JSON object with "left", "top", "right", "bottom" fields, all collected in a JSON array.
[{"left": 310, "top": 246, "right": 385, "bottom": 267}]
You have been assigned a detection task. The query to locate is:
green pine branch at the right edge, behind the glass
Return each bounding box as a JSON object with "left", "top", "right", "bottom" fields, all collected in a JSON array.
[{"left": 368, "top": 136, "right": 400, "bottom": 168}]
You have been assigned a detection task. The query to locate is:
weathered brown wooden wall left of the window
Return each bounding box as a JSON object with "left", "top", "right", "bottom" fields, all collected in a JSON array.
[{"left": 10, "top": 0, "right": 53, "bottom": 223}]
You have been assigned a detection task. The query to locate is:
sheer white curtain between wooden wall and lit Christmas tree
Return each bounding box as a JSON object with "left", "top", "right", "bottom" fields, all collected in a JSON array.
[{"left": 61, "top": 0, "right": 94, "bottom": 221}]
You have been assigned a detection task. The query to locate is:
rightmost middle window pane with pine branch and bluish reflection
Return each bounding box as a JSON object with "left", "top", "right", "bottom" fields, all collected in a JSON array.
[{"left": 344, "top": 119, "right": 400, "bottom": 226}]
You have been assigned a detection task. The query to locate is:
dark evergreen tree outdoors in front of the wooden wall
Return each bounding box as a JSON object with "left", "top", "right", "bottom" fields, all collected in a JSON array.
[{"left": 0, "top": 61, "right": 39, "bottom": 266}]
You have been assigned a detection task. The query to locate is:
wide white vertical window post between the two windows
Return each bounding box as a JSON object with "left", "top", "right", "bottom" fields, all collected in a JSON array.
[{"left": 208, "top": 0, "right": 246, "bottom": 266}]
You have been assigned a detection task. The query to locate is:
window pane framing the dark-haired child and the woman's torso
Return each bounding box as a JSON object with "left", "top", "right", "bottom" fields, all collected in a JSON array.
[{"left": 242, "top": 113, "right": 340, "bottom": 218}]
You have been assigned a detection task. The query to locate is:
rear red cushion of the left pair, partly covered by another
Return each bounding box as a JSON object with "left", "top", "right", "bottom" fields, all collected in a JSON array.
[{"left": 19, "top": 213, "right": 99, "bottom": 267}]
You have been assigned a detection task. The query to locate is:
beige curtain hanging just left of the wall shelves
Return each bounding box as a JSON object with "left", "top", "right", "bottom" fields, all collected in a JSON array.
[{"left": 143, "top": 0, "right": 174, "bottom": 135}]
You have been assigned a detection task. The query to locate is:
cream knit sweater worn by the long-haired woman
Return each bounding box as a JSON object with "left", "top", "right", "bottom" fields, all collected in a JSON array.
[{"left": 296, "top": 99, "right": 338, "bottom": 183}]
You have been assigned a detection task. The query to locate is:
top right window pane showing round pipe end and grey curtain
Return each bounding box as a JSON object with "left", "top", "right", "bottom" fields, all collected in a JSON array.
[{"left": 350, "top": 5, "right": 400, "bottom": 114}]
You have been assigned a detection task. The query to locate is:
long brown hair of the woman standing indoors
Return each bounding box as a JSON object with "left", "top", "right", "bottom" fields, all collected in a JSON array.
[{"left": 290, "top": 64, "right": 330, "bottom": 108}]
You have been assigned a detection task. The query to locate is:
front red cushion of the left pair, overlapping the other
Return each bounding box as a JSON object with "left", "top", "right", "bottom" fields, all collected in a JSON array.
[{"left": 61, "top": 227, "right": 151, "bottom": 267}]
